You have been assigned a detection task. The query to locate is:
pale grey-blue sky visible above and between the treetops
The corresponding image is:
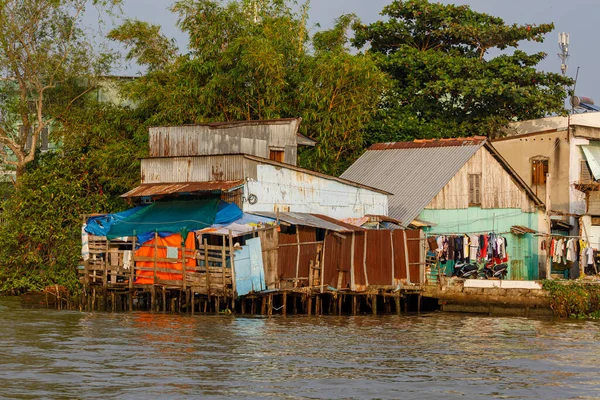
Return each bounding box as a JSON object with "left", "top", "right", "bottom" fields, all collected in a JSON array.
[{"left": 105, "top": 0, "right": 600, "bottom": 104}]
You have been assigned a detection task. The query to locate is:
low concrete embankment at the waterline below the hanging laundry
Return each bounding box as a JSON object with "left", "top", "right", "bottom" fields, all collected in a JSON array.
[{"left": 423, "top": 279, "right": 553, "bottom": 316}]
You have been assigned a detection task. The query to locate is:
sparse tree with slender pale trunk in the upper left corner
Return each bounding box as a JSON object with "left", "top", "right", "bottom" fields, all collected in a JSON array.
[{"left": 0, "top": 0, "right": 120, "bottom": 177}]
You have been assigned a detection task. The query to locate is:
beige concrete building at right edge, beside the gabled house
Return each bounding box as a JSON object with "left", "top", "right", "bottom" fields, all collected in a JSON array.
[{"left": 493, "top": 112, "right": 600, "bottom": 241}]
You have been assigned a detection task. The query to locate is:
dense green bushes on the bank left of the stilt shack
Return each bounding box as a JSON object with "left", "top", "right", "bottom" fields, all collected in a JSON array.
[{"left": 0, "top": 154, "right": 116, "bottom": 293}]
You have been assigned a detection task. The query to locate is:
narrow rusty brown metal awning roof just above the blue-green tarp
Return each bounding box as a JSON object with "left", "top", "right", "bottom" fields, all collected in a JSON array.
[{"left": 121, "top": 180, "right": 244, "bottom": 198}]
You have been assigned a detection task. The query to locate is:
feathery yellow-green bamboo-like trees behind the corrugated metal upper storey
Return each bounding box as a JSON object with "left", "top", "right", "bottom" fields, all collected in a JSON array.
[{"left": 110, "top": 0, "right": 386, "bottom": 174}]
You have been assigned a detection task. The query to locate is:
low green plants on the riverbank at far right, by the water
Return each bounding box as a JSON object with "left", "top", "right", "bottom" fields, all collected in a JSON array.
[{"left": 543, "top": 280, "right": 600, "bottom": 318}]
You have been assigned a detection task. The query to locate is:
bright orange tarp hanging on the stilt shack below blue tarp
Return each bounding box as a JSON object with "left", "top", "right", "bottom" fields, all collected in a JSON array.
[{"left": 135, "top": 232, "right": 196, "bottom": 285}]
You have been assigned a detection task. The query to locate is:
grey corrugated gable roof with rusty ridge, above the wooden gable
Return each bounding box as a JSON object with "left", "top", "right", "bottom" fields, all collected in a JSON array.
[{"left": 341, "top": 136, "right": 543, "bottom": 226}]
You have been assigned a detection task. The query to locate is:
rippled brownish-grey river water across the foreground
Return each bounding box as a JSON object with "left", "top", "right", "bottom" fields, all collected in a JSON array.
[{"left": 0, "top": 298, "right": 600, "bottom": 399}]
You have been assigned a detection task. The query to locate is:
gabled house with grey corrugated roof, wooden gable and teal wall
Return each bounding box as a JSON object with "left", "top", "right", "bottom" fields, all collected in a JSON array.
[{"left": 342, "top": 137, "right": 549, "bottom": 279}]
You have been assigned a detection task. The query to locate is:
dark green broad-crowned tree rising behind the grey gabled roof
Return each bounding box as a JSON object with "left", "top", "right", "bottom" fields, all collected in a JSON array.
[{"left": 353, "top": 0, "right": 572, "bottom": 141}]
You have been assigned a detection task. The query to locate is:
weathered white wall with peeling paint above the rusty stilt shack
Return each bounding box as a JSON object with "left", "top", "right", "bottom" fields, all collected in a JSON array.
[{"left": 243, "top": 165, "right": 388, "bottom": 219}]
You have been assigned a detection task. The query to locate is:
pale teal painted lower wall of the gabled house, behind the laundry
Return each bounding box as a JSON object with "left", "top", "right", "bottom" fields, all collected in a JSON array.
[{"left": 419, "top": 207, "right": 540, "bottom": 280}]
